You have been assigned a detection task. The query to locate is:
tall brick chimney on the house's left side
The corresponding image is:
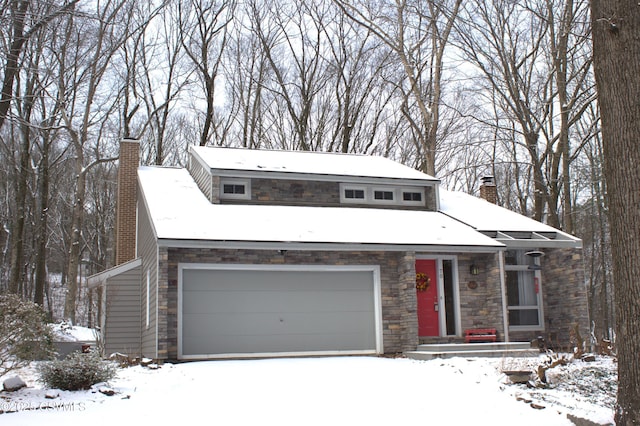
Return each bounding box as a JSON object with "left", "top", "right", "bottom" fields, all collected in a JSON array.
[{"left": 115, "top": 139, "right": 140, "bottom": 266}]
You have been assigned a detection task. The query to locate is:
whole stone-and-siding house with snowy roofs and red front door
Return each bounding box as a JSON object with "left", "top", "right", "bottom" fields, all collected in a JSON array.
[{"left": 88, "top": 140, "right": 589, "bottom": 360}]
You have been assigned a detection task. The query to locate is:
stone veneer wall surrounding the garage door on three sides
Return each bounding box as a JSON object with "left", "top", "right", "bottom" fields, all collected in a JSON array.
[{"left": 158, "top": 248, "right": 418, "bottom": 359}]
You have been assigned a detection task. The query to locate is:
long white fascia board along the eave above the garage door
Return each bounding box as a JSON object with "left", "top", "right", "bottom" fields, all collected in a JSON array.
[{"left": 158, "top": 239, "right": 506, "bottom": 253}]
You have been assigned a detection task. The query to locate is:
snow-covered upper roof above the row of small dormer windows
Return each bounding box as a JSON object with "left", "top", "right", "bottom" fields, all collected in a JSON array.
[{"left": 191, "top": 146, "right": 438, "bottom": 182}]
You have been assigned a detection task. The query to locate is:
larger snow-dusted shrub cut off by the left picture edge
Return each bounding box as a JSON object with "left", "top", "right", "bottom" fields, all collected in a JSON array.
[{"left": 0, "top": 294, "right": 54, "bottom": 376}]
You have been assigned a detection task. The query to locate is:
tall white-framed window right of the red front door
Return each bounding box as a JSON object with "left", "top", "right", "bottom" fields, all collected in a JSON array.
[{"left": 505, "top": 250, "right": 542, "bottom": 330}]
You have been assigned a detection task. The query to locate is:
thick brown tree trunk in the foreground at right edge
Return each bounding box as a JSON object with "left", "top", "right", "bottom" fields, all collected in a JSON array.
[{"left": 591, "top": 0, "right": 640, "bottom": 425}]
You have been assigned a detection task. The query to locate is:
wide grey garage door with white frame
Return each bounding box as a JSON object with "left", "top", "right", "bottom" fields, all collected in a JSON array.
[{"left": 178, "top": 264, "right": 382, "bottom": 359}]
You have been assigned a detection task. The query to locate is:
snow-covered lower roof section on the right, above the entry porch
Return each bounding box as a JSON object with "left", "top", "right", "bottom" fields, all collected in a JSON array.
[{"left": 439, "top": 188, "right": 582, "bottom": 248}]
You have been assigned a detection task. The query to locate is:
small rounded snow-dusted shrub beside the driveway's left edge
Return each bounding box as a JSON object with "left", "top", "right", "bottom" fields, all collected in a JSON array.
[{"left": 37, "top": 352, "right": 117, "bottom": 390}]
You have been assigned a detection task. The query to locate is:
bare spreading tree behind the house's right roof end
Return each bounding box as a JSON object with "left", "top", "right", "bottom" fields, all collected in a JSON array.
[{"left": 457, "top": 0, "right": 594, "bottom": 231}]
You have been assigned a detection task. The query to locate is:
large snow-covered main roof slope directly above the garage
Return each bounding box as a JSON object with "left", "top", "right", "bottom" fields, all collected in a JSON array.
[{"left": 138, "top": 167, "right": 504, "bottom": 250}]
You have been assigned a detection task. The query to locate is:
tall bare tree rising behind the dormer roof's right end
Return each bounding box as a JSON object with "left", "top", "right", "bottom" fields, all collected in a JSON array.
[{"left": 334, "top": 0, "right": 462, "bottom": 175}]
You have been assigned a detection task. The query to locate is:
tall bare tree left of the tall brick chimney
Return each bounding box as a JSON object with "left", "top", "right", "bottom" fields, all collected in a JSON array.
[{"left": 58, "top": 0, "right": 131, "bottom": 322}]
